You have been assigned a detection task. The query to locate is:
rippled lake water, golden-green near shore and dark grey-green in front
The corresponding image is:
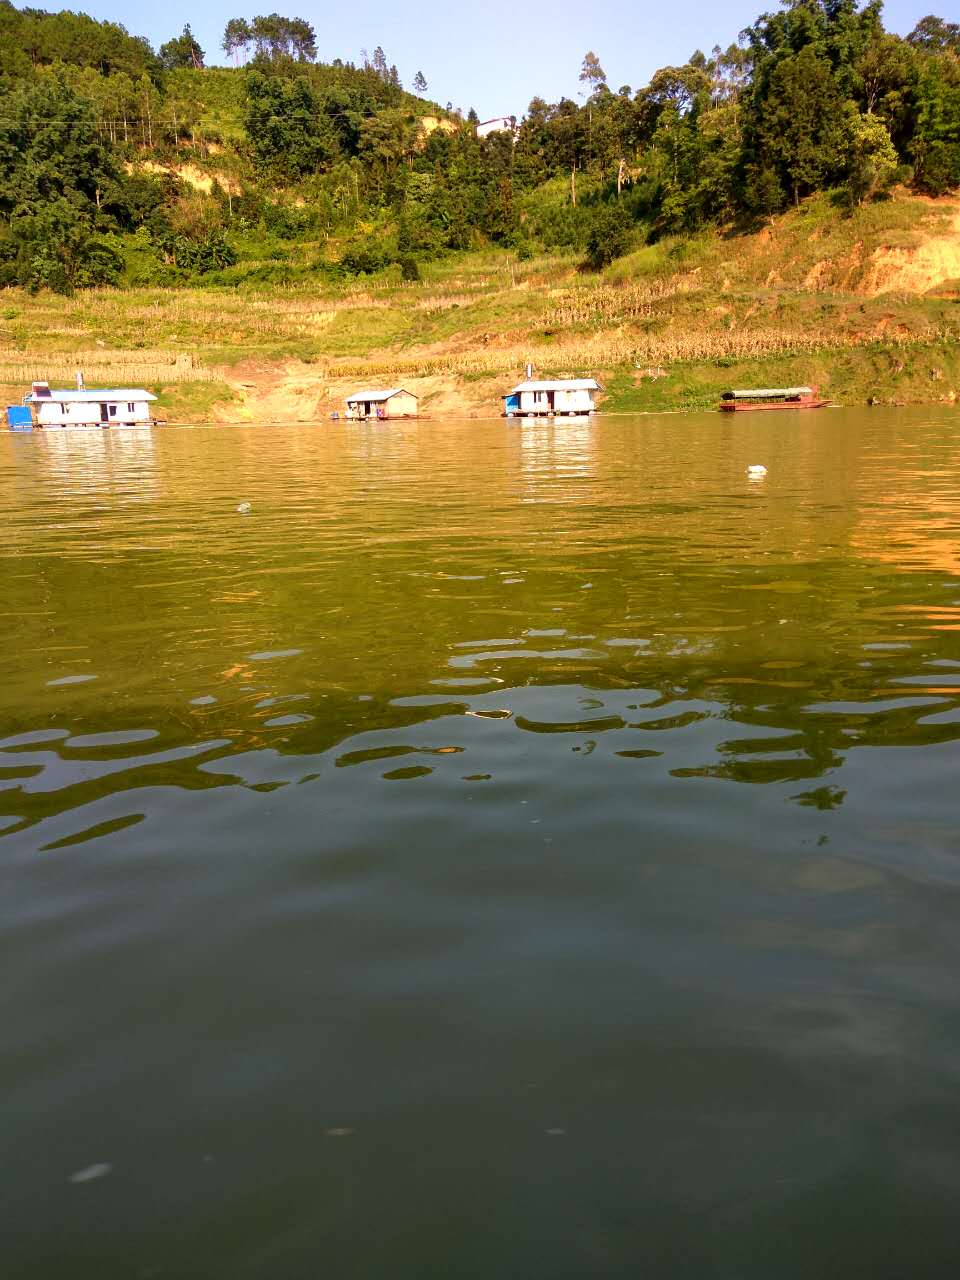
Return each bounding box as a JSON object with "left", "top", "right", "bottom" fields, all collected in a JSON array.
[{"left": 0, "top": 408, "right": 960, "bottom": 1280}]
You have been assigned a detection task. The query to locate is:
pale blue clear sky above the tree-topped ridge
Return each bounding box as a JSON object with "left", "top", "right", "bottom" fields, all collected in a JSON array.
[{"left": 30, "top": 0, "right": 957, "bottom": 120}]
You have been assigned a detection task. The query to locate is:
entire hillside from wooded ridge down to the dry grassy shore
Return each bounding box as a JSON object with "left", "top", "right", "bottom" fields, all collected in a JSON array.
[{"left": 0, "top": 0, "right": 960, "bottom": 420}]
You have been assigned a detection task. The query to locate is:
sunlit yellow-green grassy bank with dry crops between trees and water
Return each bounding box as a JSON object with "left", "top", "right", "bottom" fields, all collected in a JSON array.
[{"left": 0, "top": 195, "right": 960, "bottom": 421}]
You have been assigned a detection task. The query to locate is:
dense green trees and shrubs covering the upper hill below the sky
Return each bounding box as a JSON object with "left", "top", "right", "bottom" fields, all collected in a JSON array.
[{"left": 0, "top": 0, "right": 960, "bottom": 291}]
